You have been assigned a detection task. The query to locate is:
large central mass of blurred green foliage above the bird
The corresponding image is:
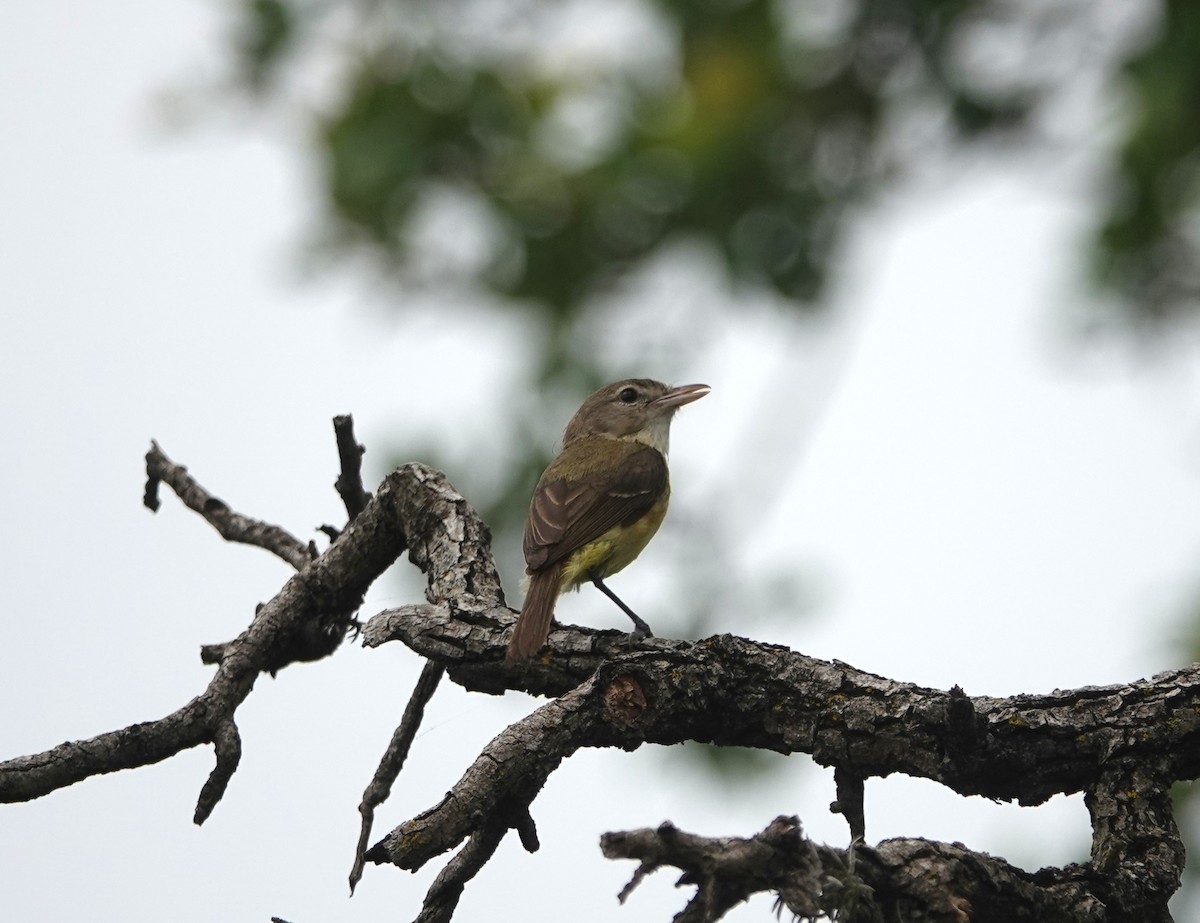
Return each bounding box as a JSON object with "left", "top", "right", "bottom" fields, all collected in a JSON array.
[{"left": 233, "top": 0, "right": 1038, "bottom": 323}]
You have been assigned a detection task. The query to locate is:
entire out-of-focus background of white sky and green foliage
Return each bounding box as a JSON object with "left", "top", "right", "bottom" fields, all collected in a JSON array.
[{"left": 0, "top": 0, "right": 1200, "bottom": 923}]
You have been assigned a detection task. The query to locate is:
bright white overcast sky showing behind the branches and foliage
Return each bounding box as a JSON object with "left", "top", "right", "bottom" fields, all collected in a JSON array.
[{"left": 0, "top": 0, "right": 1200, "bottom": 923}]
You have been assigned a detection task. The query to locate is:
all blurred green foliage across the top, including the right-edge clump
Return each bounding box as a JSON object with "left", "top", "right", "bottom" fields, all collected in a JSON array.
[{"left": 218, "top": 0, "right": 1200, "bottom": 576}]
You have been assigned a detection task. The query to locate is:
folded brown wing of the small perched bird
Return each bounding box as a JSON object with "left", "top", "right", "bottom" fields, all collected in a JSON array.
[{"left": 524, "top": 439, "right": 667, "bottom": 574}]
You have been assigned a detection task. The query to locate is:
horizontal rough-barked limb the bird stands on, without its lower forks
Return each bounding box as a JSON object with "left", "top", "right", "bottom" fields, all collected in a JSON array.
[{"left": 362, "top": 606, "right": 1200, "bottom": 804}]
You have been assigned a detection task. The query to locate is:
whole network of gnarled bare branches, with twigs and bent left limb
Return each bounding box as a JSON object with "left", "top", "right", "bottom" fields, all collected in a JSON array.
[{"left": 0, "top": 444, "right": 1200, "bottom": 923}]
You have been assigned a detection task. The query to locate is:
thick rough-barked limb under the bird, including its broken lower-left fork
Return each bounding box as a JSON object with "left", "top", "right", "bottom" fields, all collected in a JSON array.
[{"left": 364, "top": 590, "right": 1200, "bottom": 921}]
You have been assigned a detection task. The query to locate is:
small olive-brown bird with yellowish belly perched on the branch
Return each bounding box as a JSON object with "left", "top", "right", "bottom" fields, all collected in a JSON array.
[{"left": 505, "top": 378, "right": 709, "bottom": 664}]
